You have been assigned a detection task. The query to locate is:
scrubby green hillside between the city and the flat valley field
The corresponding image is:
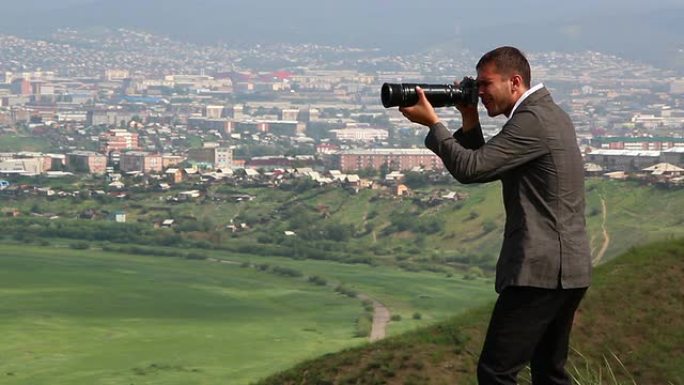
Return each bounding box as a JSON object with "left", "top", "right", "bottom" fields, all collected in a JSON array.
[{"left": 5, "top": 179, "right": 684, "bottom": 274}]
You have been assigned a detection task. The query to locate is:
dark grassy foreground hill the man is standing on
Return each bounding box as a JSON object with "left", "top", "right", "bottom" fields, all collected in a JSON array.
[{"left": 258, "top": 239, "right": 684, "bottom": 385}]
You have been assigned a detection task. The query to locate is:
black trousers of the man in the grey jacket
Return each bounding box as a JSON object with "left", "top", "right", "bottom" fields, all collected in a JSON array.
[{"left": 477, "top": 286, "right": 587, "bottom": 385}]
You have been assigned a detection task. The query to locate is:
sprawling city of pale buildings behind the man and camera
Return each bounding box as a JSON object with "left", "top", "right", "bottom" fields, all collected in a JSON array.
[{"left": 0, "top": 29, "right": 684, "bottom": 195}]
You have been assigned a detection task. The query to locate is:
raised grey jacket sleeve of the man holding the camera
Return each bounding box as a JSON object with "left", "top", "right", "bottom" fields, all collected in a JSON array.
[{"left": 425, "top": 112, "right": 548, "bottom": 184}]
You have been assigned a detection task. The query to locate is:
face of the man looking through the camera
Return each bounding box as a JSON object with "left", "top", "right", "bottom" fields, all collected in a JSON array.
[{"left": 477, "top": 63, "right": 516, "bottom": 117}]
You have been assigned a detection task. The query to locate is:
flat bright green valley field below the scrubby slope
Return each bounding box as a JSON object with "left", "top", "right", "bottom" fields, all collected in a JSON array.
[{"left": 0, "top": 242, "right": 493, "bottom": 385}]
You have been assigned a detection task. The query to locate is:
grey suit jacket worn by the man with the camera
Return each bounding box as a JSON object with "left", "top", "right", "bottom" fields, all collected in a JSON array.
[{"left": 425, "top": 88, "right": 591, "bottom": 293}]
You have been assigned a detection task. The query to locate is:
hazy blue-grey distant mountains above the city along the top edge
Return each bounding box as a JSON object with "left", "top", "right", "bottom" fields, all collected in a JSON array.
[{"left": 0, "top": 0, "right": 684, "bottom": 72}]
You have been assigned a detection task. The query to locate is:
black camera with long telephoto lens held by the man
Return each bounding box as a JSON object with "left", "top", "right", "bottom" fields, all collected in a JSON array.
[{"left": 380, "top": 77, "right": 477, "bottom": 108}]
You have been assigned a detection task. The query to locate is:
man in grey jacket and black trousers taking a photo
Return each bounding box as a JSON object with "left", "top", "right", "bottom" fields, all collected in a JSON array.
[{"left": 400, "top": 47, "right": 591, "bottom": 385}]
